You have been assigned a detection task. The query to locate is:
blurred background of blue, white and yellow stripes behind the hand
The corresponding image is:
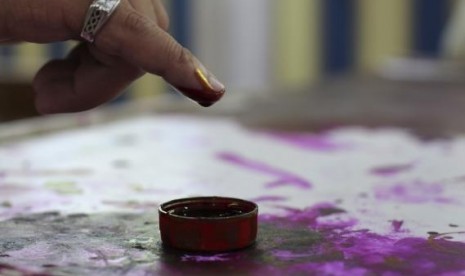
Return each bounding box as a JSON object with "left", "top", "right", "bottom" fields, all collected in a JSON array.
[{"left": 0, "top": 0, "right": 465, "bottom": 121}]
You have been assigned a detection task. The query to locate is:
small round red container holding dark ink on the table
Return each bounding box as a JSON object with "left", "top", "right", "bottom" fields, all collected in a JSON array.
[{"left": 158, "top": 197, "right": 258, "bottom": 252}]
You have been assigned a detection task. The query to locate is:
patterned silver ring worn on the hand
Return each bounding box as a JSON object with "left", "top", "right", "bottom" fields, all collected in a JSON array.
[{"left": 81, "top": 0, "right": 121, "bottom": 43}]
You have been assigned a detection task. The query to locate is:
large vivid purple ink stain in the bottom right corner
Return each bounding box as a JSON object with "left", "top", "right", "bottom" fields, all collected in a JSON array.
[{"left": 261, "top": 204, "right": 465, "bottom": 275}]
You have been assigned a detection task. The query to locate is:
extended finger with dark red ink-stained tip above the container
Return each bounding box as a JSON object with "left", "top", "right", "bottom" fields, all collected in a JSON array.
[{"left": 95, "top": 1, "right": 225, "bottom": 106}]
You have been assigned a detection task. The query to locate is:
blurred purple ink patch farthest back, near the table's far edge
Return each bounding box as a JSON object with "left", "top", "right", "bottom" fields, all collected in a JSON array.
[{"left": 260, "top": 132, "right": 348, "bottom": 151}]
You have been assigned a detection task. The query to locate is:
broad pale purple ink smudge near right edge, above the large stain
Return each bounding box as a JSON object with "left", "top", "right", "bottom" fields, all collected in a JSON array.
[{"left": 375, "top": 181, "right": 453, "bottom": 204}]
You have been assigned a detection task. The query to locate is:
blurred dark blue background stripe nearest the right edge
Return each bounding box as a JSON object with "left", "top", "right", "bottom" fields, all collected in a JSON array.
[{"left": 413, "top": 0, "right": 449, "bottom": 57}]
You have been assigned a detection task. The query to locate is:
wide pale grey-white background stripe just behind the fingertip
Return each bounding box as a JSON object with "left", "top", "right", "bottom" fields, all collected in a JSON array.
[{"left": 193, "top": 0, "right": 273, "bottom": 91}]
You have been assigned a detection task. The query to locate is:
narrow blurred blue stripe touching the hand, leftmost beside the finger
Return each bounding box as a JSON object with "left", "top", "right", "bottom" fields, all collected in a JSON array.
[{"left": 171, "top": 0, "right": 192, "bottom": 48}]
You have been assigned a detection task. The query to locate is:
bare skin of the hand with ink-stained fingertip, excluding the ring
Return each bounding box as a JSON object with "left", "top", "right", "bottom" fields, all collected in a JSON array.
[{"left": 0, "top": 0, "right": 225, "bottom": 114}]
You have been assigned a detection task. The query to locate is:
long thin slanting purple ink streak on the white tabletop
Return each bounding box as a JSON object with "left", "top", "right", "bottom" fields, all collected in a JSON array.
[{"left": 217, "top": 152, "right": 312, "bottom": 189}]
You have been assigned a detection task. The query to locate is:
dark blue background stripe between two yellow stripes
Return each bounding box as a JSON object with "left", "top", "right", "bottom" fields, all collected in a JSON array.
[{"left": 322, "top": 0, "right": 355, "bottom": 74}]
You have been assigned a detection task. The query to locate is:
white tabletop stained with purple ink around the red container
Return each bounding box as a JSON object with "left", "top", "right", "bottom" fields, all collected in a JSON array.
[{"left": 0, "top": 115, "right": 465, "bottom": 275}]
